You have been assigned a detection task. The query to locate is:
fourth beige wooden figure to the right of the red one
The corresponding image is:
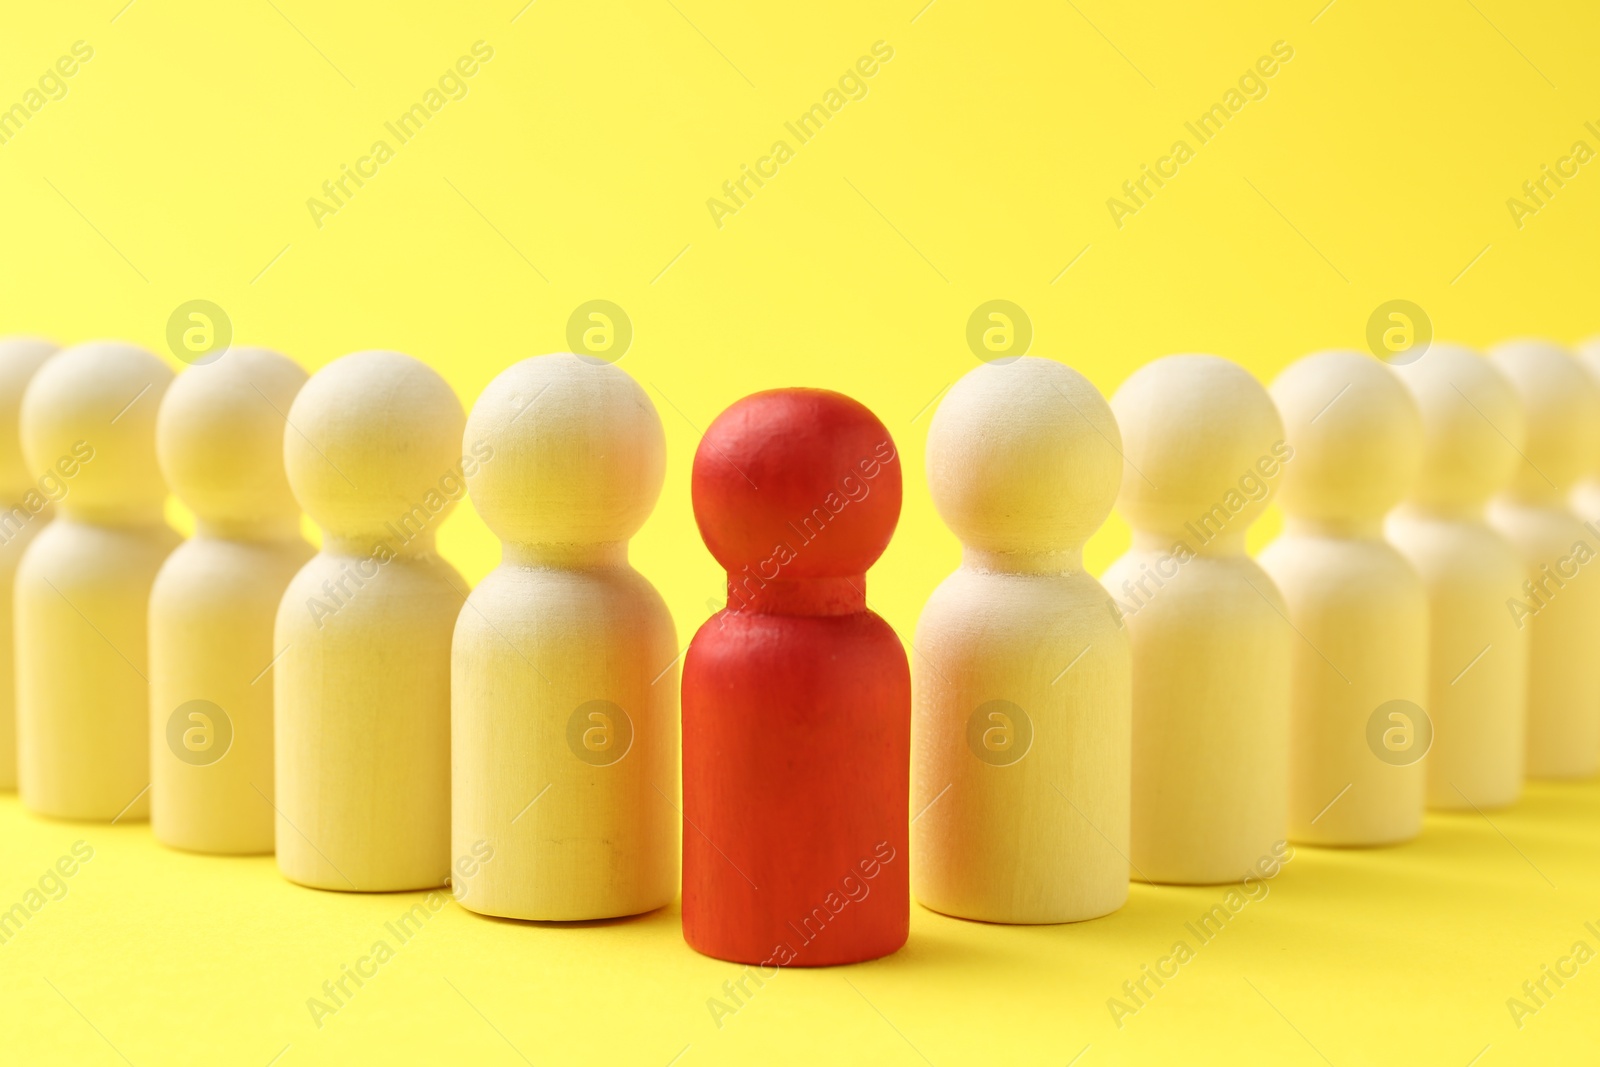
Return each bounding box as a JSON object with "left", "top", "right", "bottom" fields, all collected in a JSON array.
[{"left": 1386, "top": 342, "right": 1528, "bottom": 811}]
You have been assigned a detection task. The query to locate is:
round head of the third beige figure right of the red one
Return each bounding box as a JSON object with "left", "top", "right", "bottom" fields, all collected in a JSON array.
[{"left": 1270, "top": 352, "right": 1422, "bottom": 523}]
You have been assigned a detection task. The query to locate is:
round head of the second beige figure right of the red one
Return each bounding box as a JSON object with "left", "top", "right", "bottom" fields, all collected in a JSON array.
[{"left": 1110, "top": 355, "right": 1290, "bottom": 552}]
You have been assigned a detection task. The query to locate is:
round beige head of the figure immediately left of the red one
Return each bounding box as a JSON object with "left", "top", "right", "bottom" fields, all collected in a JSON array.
[{"left": 462, "top": 352, "right": 667, "bottom": 544}]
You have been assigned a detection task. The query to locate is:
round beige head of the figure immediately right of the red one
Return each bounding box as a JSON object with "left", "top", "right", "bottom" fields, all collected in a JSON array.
[{"left": 928, "top": 357, "right": 1123, "bottom": 557}]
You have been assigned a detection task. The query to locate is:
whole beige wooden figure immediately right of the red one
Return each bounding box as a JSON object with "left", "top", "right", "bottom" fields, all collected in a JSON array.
[{"left": 912, "top": 357, "right": 1131, "bottom": 923}]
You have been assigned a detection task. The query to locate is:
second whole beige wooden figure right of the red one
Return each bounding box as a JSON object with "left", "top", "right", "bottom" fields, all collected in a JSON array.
[{"left": 1101, "top": 355, "right": 1293, "bottom": 885}]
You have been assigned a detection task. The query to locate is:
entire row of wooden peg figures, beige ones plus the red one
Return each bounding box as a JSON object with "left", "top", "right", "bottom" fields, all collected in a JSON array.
[{"left": 0, "top": 341, "right": 1600, "bottom": 965}]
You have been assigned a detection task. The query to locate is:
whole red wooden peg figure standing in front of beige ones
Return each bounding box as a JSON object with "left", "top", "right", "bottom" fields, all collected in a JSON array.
[{"left": 683, "top": 389, "right": 910, "bottom": 968}]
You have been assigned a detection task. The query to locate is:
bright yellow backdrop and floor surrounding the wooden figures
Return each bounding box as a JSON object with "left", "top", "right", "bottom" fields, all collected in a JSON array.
[{"left": 0, "top": 0, "right": 1600, "bottom": 1067}]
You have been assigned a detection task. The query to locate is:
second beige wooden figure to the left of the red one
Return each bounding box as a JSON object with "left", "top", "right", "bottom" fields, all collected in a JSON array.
[{"left": 274, "top": 352, "right": 466, "bottom": 891}]
